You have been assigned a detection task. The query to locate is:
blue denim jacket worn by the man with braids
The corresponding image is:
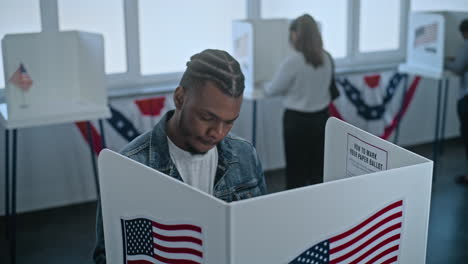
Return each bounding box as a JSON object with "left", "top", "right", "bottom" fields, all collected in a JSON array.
[{"left": 93, "top": 111, "right": 267, "bottom": 264}]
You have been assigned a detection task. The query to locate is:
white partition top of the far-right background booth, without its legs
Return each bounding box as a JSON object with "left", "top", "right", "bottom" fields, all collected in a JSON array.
[{"left": 399, "top": 12, "right": 468, "bottom": 79}]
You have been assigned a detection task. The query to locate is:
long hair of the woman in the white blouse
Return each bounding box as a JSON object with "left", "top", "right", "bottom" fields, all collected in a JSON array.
[{"left": 289, "top": 14, "right": 323, "bottom": 67}]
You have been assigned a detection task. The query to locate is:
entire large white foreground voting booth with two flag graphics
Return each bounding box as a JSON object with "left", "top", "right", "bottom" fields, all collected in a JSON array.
[{"left": 99, "top": 118, "right": 433, "bottom": 264}]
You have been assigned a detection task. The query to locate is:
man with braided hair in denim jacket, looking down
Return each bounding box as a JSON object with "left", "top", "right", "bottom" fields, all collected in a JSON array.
[{"left": 93, "top": 50, "right": 266, "bottom": 263}]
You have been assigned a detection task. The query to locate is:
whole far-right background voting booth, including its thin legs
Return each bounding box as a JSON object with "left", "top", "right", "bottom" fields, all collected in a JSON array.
[{"left": 398, "top": 12, "right": 468, "bottom": 174}]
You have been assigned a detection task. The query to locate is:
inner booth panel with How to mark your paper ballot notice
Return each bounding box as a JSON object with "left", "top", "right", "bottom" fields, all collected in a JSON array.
[{"left": 324, "top": 118, "right": 432, "bottom": 182}]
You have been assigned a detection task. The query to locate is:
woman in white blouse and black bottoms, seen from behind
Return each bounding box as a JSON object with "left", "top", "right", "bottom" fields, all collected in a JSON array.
[{"left": 265, "top": 14, "right": 333, "bottom": 189}]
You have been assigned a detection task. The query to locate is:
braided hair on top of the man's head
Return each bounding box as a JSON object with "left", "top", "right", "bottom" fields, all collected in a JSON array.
[{"left": 180, "top": 49, "right": 244, "bottom": 98}]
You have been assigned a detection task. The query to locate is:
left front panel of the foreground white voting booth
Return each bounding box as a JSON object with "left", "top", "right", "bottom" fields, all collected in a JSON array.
[{"left": 99, "top": 152, "right": 229, "bottom": 263}]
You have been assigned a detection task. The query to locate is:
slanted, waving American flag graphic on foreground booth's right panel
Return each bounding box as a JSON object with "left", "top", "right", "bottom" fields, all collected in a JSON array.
[{"left": 290, "top": 200, "right": 403, "bottom": 264}]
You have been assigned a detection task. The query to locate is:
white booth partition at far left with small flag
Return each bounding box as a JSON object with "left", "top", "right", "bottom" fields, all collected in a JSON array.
[{"left": 0, "top": 31, "right": 110, "bottom": 128}]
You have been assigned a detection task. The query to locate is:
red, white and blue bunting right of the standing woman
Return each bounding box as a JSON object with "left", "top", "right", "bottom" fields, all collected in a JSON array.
[{"left": 330, "top": 72, "right": 421, "bottom": 139}]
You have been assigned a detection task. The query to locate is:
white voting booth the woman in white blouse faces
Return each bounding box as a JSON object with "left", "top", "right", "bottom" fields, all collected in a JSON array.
[{"left": 232, "top": 19, "right": 292, "bottom": 98}]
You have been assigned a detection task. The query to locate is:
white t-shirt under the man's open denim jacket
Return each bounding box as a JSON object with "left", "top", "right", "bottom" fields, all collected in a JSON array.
[{"left": 167, "top": 137, "right": 218, "bottom": 194}]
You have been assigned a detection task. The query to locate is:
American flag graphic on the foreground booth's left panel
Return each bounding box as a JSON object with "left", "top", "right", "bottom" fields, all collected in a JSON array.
[{"left": 121, "top": 218, "right": 203, "bottom": 264}]
